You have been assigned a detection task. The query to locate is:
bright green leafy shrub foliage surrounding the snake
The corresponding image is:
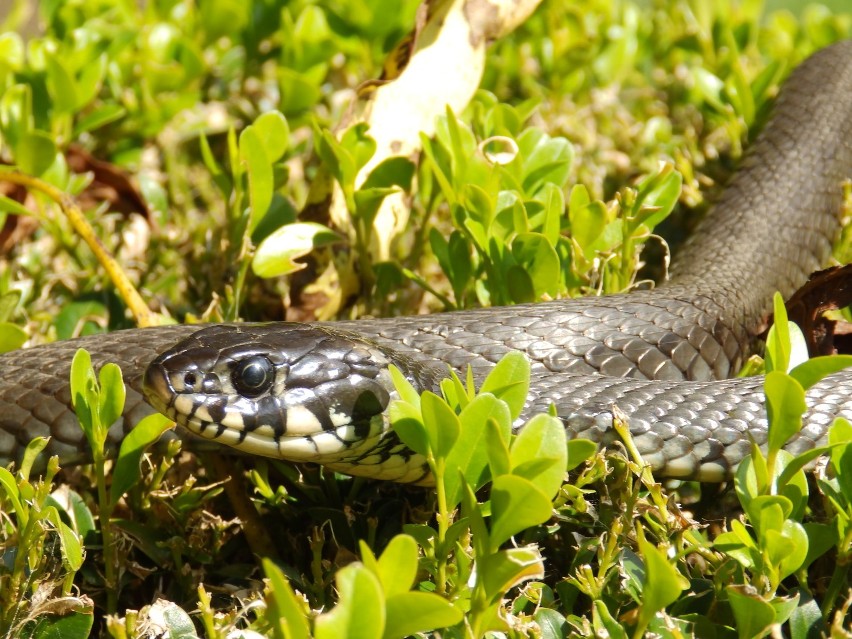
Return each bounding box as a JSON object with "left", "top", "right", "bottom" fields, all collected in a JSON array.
[{"left": 0, "top": 0, "right": 852, "bottom": 638}]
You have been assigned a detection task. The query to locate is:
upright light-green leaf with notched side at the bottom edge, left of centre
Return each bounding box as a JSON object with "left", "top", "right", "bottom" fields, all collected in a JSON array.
[{"left": 314, "top": 564, "right": 385, "bottom": 639}]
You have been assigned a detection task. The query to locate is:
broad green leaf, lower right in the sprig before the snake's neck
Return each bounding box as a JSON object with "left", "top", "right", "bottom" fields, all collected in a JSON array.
[{"left": 491, "top": 475, "right": 551, "bottom": 551}]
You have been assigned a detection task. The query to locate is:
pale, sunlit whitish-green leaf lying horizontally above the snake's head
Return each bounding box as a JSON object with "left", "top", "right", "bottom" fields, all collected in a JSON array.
[{"left": 251, "top": 222, "right": 343, "bottom": 278}]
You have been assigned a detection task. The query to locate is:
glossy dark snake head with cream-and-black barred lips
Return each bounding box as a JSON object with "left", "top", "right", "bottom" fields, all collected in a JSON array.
[{"left": 143, "top": 322, "right": 422, "bottom": 476}]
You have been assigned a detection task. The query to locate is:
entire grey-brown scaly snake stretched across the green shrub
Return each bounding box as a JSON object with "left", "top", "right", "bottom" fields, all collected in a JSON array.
[{"left": 0, "top": 41, "right": 852, "bottom": 483}]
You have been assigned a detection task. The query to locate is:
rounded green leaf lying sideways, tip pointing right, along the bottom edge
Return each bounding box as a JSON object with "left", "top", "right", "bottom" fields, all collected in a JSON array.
[{"left": 382, "top": 592, "right": 463, "bottom": 639}]
